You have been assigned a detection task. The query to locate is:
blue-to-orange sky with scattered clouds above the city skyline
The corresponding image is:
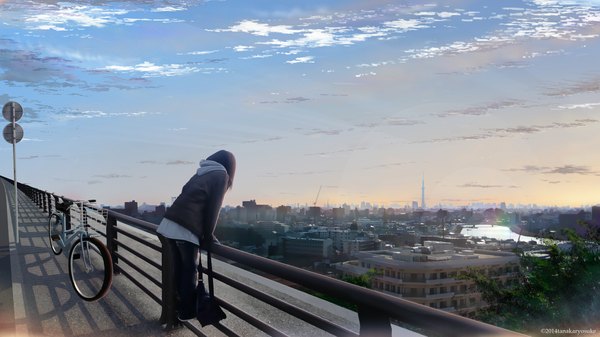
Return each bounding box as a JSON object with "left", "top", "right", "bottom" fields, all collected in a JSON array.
[{"left": 0, "top": 0, "right": 600, "bottom": 207}]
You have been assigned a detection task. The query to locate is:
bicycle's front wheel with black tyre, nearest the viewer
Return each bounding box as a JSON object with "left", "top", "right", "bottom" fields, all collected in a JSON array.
[{"left": 69, "top": 237, "right": 113, "bottom": 301}]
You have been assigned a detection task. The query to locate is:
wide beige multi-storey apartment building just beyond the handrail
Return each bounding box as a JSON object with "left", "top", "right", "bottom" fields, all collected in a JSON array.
[{"left": 336, "top": 241, "right": 519, "bottom": 316}]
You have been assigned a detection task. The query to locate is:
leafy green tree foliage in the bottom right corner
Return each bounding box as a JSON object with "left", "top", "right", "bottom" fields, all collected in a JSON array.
[{"left": 466, "top": 227, "right": 600, "bottom": 334}]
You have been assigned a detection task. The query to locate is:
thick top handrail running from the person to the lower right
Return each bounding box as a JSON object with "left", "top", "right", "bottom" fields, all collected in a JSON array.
[{"left": 210, "top": 243, "right": 522, "bottom": 336}]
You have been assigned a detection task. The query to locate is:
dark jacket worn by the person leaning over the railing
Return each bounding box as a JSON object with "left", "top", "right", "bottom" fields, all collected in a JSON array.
[{"left": 165, "top": 171, "right": 229, "bottom": 244}]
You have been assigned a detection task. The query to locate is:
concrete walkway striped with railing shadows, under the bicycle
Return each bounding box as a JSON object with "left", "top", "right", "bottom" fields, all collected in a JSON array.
[{"left": 0, "top": 180, "right": 193, "bottom": 337}]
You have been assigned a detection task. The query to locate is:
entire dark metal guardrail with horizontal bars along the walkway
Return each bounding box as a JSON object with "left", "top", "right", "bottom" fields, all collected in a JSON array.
[{"left": 2, "top": 177, "right": 522, "bottom": 337}]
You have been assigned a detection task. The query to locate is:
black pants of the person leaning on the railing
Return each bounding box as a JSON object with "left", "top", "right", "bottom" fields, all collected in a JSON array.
[{"left": 169, "top": 239, "right": 200, "bottom": 319}]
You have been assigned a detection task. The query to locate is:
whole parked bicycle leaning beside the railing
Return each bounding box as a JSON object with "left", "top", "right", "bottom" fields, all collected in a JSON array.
[{"left": 48, "top": 200, "right": 113, "bottom": 302}]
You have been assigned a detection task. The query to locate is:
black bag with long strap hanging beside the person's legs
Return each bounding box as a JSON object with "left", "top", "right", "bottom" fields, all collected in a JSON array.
[{"left": 196, "top": 249, "right": 227, "bottom": 327}]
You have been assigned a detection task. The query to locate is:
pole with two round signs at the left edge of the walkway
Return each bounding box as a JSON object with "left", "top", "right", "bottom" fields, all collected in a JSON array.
[{"left": 2, "top": 102, "right": 23, "bottom": 244}]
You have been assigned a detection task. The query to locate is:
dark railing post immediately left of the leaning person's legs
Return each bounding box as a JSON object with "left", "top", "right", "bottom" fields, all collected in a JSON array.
[{"left": 158, "top": 234, "right": 181, "bottom": 329}]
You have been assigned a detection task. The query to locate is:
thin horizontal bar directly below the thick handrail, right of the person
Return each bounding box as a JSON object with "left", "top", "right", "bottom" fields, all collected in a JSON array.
[{"left": 210, "top": 271, "right": 358, "bottom": 337}]
